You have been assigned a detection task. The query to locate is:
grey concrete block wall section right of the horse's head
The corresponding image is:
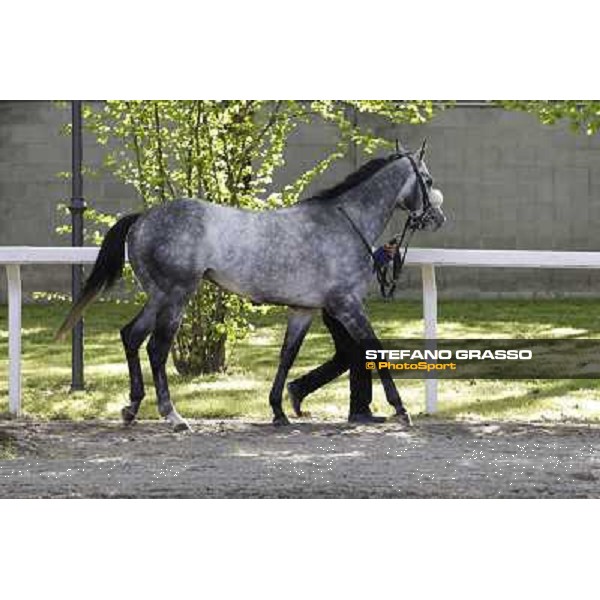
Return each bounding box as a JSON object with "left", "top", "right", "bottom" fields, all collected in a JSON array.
[{"left": 368, "top": 106, "right": 600, "bottom": 297}]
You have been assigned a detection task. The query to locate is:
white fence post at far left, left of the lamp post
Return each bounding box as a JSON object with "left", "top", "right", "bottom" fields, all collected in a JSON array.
[{"left": 6, "top": 265, "right": 21, "bottom": 417}]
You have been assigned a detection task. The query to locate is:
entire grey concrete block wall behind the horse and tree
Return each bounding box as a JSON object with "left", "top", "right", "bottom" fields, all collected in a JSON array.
[{"left": 0, "top": 101, "right": 600, "bottom": 301}]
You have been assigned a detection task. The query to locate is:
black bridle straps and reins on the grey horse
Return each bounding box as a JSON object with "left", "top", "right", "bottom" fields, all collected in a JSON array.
[{"left": 338, "top": 152, "right": 432, "bottom": 298}]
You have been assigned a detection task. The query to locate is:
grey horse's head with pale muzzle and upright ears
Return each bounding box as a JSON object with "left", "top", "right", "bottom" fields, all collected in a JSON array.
[{"left": 397, "top": 140, "right": 446, "bottom": 231}]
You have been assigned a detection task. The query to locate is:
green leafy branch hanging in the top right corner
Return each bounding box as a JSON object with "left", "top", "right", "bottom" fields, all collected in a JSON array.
[{"left": 498, "top": 100, "right": 600, "bottom": 135}]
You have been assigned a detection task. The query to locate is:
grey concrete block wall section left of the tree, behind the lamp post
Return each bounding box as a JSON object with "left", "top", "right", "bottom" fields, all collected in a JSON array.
[{"left": 0, "top": 101, "right": 139, "bottom": 302}]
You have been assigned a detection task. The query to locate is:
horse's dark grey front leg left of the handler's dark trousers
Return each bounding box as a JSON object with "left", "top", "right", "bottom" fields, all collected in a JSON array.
[{"left": 269, "top": 308, "right": 313, "bottom": 425}]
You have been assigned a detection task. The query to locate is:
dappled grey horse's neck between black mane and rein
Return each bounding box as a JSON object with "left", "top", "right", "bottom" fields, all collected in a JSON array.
[{"left": 344, "top": 164, "right": 403, "bottom": 244}]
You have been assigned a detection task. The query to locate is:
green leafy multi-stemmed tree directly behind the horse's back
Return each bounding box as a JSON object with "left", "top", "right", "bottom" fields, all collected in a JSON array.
[{"left": 85, "top": 100, "right": 434, "bottom": 375}]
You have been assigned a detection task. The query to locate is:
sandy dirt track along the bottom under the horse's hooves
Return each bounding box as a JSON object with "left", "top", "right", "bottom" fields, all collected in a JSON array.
[{"left": 0, "top": 419, "right": 600, "bottom": 498}]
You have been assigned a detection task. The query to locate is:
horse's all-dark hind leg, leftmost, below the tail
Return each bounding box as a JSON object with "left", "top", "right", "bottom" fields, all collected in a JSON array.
[{"left": 121, "top": 302, "right": 156, "bottom": 425}]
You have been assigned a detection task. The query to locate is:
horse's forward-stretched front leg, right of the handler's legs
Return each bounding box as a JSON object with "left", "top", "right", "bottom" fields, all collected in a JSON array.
[{"left": 327, "top": 295, "right": 411, "bottom": 425}]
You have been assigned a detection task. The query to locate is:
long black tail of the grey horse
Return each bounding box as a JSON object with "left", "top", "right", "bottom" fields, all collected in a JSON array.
[{"left": 55, "top": 213, "right": 140, "bottom": 339}]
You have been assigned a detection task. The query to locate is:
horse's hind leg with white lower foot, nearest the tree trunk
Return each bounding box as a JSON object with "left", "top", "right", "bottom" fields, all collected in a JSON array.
[{"left": 147, "top": 291, "right": 190, "bottom": 431}]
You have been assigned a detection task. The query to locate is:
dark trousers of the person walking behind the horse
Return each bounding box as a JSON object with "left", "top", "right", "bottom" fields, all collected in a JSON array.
[{"left": 290, "top": 311, "right": 373, "bottom": 414}]
